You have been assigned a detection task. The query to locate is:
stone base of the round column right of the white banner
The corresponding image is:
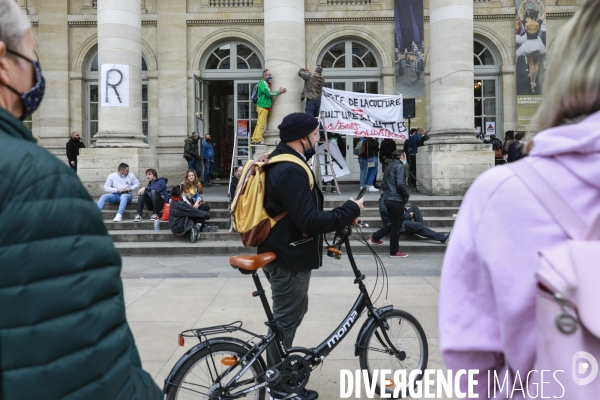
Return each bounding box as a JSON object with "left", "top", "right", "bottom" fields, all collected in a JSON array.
[{"left": 417, "top": 143, "right": 495, "bottom": 196}]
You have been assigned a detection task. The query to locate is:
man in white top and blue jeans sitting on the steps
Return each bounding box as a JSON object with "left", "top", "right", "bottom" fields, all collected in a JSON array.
[{"left": 97, "top": 163, "right": 140, "bottom": 222}]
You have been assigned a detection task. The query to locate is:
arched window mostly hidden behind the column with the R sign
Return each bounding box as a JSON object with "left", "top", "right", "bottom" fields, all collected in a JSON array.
[{"left": 83, "top": 53, "right": 148, "bottom": 147}]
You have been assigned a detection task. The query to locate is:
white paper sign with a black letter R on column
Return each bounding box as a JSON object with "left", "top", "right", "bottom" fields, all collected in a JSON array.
[{"left": 100, "top": 64, "right": 129, "bottom": 107}]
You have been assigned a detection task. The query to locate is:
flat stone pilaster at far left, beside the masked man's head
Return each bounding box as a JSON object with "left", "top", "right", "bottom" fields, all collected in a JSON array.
[{"left": 33, "top": 0, "right": 70, "bottom": 161}]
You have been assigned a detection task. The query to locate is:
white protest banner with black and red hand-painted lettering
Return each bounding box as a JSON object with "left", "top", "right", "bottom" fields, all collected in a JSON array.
[{"left": 321, "top": 88, "right": 408, "bottom": 139}]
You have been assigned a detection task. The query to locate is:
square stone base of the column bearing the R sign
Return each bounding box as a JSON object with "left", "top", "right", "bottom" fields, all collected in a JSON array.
[{"left": 77, "top": 147, "right": 160, "bottom": 197}]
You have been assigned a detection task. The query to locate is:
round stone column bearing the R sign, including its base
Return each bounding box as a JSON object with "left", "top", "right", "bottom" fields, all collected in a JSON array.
[{"left": 77, "top": 0, "right": 158, "bottom": 196}]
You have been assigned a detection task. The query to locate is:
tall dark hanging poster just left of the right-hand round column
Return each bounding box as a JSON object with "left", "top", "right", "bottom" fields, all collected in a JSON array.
[{"left": 394, "top": 0, "right": 427, "bottom": 128}]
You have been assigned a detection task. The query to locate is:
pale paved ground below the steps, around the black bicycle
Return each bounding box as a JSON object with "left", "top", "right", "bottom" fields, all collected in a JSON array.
[{"left": 122, "top": 254, "right": 458, "bottom": 399}]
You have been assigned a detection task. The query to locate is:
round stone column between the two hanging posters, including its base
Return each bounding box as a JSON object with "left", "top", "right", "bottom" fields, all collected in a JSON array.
[{"left": 417, "top": 0, "right": 494, "bottom": 195}]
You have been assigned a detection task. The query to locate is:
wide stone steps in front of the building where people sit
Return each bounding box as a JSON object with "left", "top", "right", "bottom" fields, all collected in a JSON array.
[{"left": 102, "top": 185, "right": 462, "bottom": 256}]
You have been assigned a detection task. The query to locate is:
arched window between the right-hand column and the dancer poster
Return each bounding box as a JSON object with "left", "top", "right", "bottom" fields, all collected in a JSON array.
[{"left": 473, "top": 40, "right": 502, "bottom": 138}]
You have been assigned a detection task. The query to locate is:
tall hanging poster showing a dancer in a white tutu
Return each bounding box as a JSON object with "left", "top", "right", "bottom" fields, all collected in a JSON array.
[{"left": 515, "top": 0, "right": 547, "bottom": 131}]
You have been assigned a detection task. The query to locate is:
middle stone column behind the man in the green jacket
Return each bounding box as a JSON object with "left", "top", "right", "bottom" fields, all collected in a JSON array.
[{"left": 257, "top": 0, "right": 304, "bottom": 153}]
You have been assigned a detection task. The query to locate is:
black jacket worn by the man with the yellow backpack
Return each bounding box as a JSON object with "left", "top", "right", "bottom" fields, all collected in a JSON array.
[{"left": 258, "top": 142, "right": 360, "bottom": 271}]
